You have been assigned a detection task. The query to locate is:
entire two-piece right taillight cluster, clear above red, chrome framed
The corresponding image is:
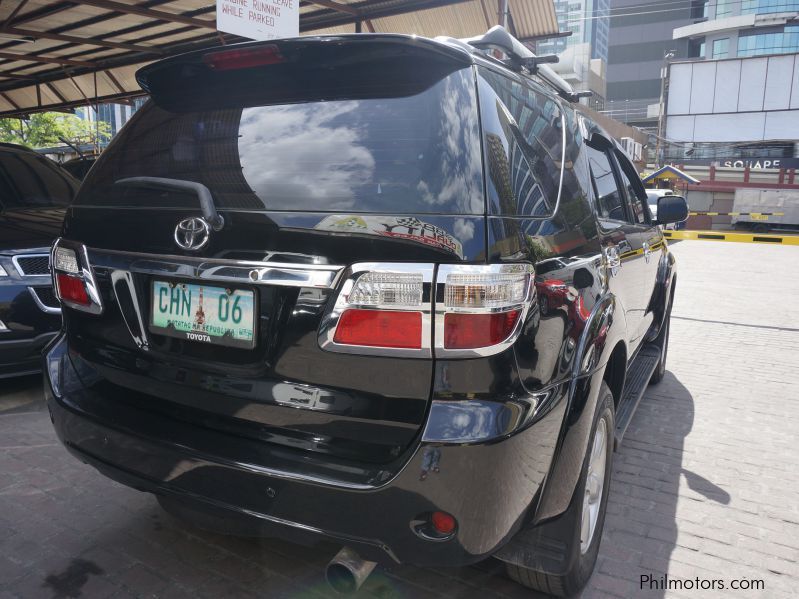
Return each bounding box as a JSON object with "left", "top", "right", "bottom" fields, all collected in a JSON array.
[{"left": 319, "top": 263, "right": 534, "bottom": 358}]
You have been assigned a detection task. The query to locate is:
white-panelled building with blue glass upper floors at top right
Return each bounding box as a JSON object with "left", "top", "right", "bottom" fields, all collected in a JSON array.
[{"left": 664, "top": 0, "right": 799, "bottom": 163}]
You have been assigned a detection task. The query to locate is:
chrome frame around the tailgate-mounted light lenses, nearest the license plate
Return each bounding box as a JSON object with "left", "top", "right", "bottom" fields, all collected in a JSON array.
[{"left": 318, "top": 262, "right": 435, "bottom": 358}]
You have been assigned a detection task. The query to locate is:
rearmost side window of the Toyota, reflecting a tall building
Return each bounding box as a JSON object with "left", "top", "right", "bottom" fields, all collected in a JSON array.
[{"left": 478, "top": 68, "right": 563, "bottom": 218}]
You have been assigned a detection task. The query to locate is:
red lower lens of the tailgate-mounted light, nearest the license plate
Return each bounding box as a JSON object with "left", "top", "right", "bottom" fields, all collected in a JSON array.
[{"left": 333, "top": 309, "right": 422, "bottom": 349}]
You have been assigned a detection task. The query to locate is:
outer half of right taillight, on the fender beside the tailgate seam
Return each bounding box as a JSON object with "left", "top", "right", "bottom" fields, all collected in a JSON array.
[{"left": 435, "top": 264, "right": 534, "bottom": 357}]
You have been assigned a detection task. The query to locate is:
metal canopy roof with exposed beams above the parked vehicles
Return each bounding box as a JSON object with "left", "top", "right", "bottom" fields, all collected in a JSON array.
[{"left": 0, "top": 0, "right": 558, "bottom": 116}]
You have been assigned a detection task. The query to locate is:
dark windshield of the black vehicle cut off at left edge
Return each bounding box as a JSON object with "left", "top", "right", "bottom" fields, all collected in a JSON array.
[{"left": 0, "top": 150, "right": 78, "bottom": 210}]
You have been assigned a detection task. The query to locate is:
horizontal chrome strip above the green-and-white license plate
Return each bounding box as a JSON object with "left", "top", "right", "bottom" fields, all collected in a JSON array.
[{"left": 88, "top": 248, "right": 344, "bottom": 289}]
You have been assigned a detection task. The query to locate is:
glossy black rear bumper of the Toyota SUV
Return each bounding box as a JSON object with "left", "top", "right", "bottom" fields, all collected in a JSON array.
[{"left": 45, "top": 342, "right": 566, "bottom": 566}]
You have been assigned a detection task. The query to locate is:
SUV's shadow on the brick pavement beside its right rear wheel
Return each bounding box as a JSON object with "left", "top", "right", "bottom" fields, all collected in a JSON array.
[{"left": 584, "top": 371, "right": 730, "bottom": 599}]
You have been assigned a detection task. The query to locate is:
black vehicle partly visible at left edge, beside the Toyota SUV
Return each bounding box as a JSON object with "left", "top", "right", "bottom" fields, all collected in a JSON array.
[{"left": 0, "top": 143, "right": 78, "bottom": 379}]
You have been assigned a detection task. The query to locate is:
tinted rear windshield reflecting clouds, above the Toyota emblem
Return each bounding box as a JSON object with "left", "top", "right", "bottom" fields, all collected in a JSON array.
[{"left": 77, "top": 68, "right": 484, "bottom": 214}]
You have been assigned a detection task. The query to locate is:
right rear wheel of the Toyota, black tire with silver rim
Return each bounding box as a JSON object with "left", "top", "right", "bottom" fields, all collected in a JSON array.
[{"left": 505, "top": 381, "right": 616, "bottom": 597}]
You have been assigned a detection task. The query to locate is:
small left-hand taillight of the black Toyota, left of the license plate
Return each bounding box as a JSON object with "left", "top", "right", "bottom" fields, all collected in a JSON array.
[{"left": 50, "top": 239, "right": 103, "bottom": 314}]
